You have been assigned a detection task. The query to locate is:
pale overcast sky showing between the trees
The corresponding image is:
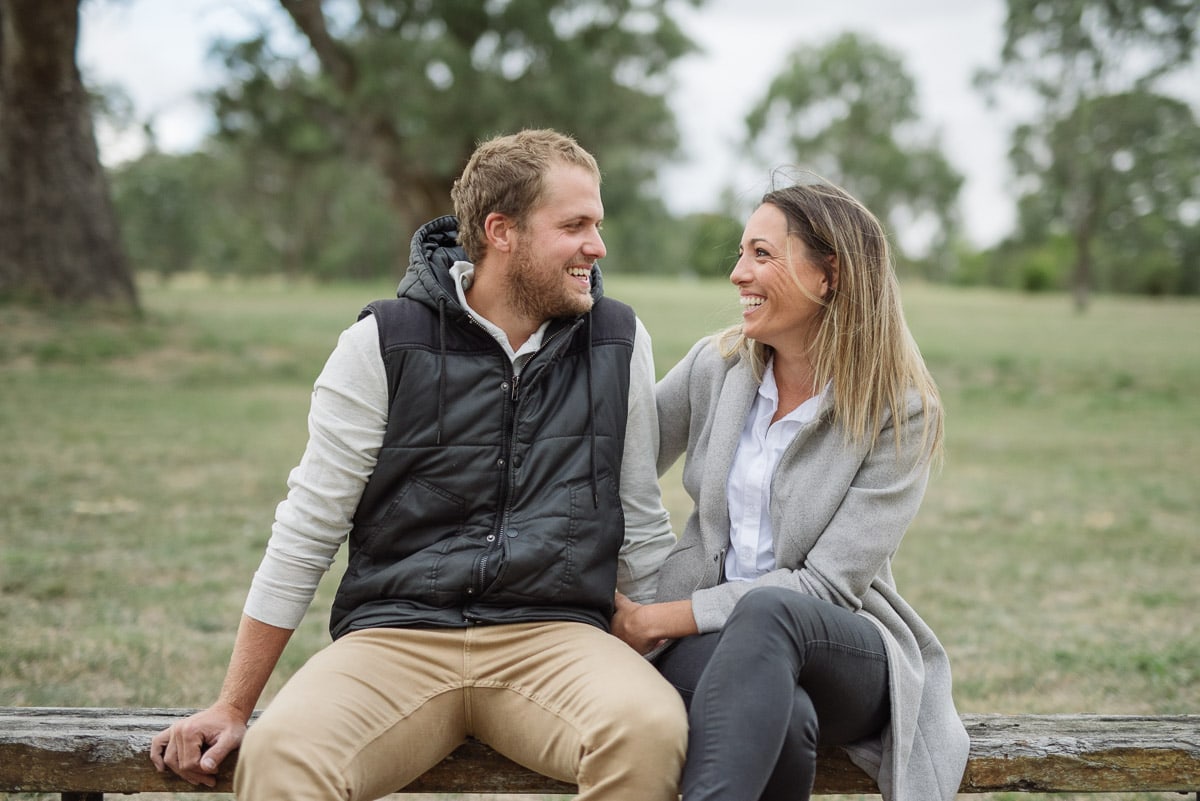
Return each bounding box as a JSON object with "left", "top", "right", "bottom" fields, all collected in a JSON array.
[{"left": 79, "top": 0, "right": 1013, "bottom": 246}]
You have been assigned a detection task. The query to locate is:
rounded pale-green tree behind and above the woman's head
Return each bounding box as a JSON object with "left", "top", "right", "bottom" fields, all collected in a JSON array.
[{"left": 746, "top": 34, "right": 962, "bottom": 270}]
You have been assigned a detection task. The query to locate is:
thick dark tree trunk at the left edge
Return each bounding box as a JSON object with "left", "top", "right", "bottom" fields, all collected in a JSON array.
[{"left": 0, "top": 0, "right": 138, "bottom": 312}]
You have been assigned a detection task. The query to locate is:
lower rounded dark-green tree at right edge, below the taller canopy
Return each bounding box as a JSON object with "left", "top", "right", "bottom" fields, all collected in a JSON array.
[{"left": 1013, "top": 91, "right": 1200, "bottom": 297}]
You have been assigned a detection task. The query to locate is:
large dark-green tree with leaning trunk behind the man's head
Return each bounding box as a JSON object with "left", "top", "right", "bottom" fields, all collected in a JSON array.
[{"left": 215, "top": 0, "right": 700, "bottom": 268}]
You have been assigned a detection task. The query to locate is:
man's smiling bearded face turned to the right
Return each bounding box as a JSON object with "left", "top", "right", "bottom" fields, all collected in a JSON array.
[{"left": 508, "top": 163, "right": 606, "bottom": 321}]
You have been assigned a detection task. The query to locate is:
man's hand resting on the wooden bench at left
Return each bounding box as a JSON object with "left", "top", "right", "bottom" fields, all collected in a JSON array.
[{"left": 150, "top": 701, "right": 246, "bottom": 787}]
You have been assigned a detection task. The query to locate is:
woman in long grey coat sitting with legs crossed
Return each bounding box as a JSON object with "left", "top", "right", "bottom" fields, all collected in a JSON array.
[{"left": 613, "top": 176, "right": 968, "bottom": 801}]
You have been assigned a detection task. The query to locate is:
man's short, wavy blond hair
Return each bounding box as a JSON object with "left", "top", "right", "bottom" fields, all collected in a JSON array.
[{"left": 450, "top": 128, "right": 600, "bottom": 263}]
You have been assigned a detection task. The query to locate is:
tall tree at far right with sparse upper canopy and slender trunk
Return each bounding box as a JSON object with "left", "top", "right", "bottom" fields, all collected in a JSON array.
[{"left": 979, "top": 0, "right": 1200, "bottom": 311}]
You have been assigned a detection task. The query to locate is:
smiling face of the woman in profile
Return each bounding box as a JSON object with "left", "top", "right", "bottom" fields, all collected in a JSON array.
[{"left": 730, "top": 204, "right": 829, "bottom": 350}]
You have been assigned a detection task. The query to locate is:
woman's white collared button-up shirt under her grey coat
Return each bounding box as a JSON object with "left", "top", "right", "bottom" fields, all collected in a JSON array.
[{"left": 725, "top": 362, "right": 829, "bottom": 582}]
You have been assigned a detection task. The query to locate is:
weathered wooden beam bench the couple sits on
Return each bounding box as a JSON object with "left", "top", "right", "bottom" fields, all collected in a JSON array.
[{"left": 0, "top": 707, "right": 1200, "bottom": 801}]
